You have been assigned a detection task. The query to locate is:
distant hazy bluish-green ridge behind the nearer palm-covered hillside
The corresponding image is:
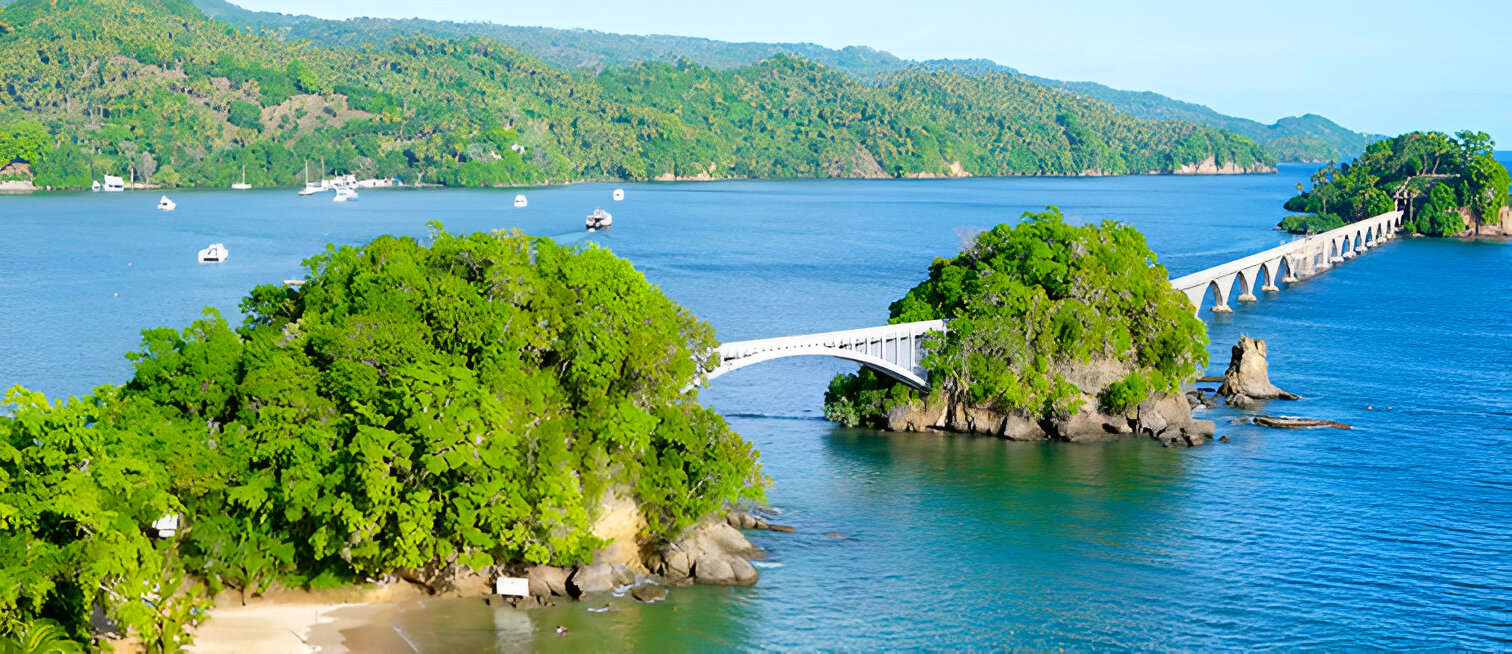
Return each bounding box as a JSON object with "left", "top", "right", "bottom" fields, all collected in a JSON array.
[{"left": 182, "top": 0, "right": 1385, "bottom": 162}]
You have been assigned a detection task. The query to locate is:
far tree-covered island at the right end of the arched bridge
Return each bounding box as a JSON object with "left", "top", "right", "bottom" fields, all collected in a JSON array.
[{"left": 1278, "top": 131, "right": 1512, "bottom": 236}]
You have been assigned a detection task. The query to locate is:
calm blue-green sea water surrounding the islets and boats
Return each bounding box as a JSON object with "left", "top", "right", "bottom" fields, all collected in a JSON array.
[{"left": 0, "top": 153, "right": 1512, "bottom": 652}]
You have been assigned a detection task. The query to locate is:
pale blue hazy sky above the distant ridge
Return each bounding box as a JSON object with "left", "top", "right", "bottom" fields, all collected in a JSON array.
[{"left": 233, "top": 0, "right": 1512, "bottom": 144}]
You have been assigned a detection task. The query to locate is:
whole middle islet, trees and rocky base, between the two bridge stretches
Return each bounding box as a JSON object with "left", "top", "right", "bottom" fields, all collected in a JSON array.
[{"left": 824, "top": 207, "right": 1214, "bottom": 446}]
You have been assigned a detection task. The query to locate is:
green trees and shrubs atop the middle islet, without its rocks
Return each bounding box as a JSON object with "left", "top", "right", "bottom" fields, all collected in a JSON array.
[{"left": 826, "top": 207, "right": 1208, "bottom": 421}]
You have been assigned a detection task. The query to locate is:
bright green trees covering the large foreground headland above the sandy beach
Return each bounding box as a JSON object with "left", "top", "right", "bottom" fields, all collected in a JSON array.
[{"left": 0, "top": 233, "right": 764, "bottom": 646}]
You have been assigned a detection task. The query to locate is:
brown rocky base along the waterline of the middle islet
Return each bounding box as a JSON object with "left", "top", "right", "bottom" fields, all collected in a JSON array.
[{"left": 888, "top": 386, "right": 1216, "bottom": 446}]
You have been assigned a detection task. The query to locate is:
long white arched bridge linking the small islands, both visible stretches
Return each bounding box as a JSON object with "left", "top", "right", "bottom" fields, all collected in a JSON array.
[{"left": 709, "top": 211, "right": 1403, "bottom": 390}]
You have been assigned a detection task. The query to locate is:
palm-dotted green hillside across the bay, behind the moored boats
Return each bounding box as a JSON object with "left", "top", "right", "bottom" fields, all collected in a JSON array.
[{"left": 0, "top": 0, "right": 1273, "bottom": 187}]
